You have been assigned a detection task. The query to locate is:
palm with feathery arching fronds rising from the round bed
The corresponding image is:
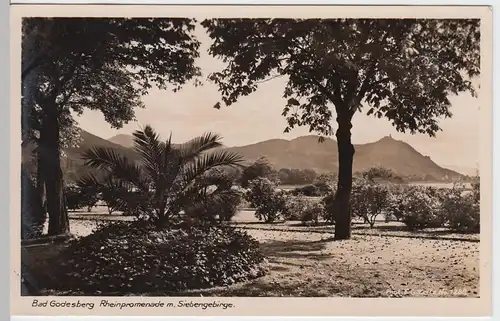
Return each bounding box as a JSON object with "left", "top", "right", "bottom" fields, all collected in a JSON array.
[{"left": 83, "top": 125, "right": 243, "bottom": 226}]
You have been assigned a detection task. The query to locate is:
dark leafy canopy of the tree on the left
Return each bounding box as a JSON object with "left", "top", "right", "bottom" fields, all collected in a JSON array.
[{"left": 22, "top": 18, "right": 199, "bottom": 142}]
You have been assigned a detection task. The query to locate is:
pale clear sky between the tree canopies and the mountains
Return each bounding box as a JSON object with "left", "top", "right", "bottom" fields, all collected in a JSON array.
[{"left": 77, "top": 26, "right": 480, "bottom": 174}]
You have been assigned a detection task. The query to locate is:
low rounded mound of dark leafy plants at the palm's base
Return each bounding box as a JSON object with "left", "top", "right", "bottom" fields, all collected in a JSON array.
[{"left": 54, "top": 221, "right": 264, "bottom": 295}]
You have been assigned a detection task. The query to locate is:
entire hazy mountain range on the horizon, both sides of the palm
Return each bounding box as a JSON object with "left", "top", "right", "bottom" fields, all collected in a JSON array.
[{"left": 49, "top": 130, "right": 464, "bottom": 181}]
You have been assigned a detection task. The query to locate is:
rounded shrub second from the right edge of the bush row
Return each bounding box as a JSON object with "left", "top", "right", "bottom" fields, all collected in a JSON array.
[{"left": 401, "top": 187, "right": 445, "bottom": 230}]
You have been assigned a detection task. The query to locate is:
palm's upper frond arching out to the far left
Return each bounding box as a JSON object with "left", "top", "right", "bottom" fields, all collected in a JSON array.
[{"left": 82, "top": 147, "right": 149, "bottom": 190}]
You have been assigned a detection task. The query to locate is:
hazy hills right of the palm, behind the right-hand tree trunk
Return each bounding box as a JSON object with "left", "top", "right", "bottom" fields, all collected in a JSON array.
[{"left": 228, "top": 135, "right": 462, "bottom": 181}]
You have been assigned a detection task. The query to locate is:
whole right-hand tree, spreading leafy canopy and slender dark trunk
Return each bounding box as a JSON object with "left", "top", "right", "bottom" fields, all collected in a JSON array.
[{"left": 202, "top": 18, "right": 480, "bottom": 239}]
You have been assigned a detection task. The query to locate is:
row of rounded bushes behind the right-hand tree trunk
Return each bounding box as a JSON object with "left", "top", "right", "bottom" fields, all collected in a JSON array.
[{"left": 246, "top": 177, "right": 480, "bottom": 232}]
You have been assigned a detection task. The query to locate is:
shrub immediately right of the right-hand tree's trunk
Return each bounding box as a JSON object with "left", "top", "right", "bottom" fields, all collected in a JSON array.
[{"left": 350, "top": 179, "right": 389, "bottom": 227}]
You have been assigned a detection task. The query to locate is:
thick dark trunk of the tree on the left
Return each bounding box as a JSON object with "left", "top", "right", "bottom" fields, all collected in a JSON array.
[{"left": 40, "top": 101, "right": 69, "bottom": 235}]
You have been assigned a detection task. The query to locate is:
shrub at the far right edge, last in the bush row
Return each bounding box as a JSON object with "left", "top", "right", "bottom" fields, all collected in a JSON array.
[{"left": 442, "top": 188, "right": 480, "bottom": 233}]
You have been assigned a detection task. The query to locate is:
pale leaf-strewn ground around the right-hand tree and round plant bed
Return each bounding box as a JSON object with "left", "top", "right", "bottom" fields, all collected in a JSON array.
[{"left": 28, "top": 209, "right": 479, "bottom": 297}]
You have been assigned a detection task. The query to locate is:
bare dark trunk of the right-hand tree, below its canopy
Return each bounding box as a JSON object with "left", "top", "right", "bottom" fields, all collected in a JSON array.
[{"left": 335, "top": 116, "right": 354, "bottom": 240}]
